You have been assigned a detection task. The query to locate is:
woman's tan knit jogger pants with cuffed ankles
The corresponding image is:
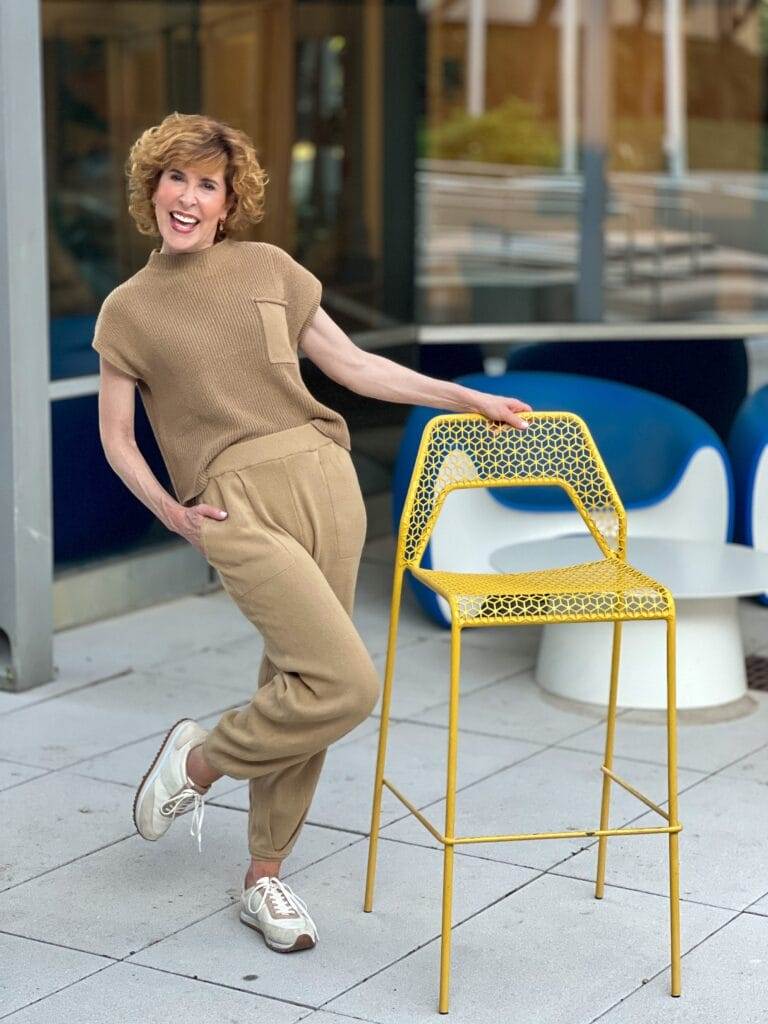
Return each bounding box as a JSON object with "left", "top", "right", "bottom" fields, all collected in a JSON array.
[{"left": 198, "top": 423, "right": 381, "bottom": 860}]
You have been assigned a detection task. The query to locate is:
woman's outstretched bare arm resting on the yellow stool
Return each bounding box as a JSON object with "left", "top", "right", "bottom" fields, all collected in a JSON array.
[{"left": 301, "top": 306, "right": 530, "bottom": 430}]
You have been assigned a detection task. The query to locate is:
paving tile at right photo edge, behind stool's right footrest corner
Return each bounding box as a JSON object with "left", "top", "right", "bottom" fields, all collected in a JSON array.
[{"left": 556, "top": 775, "right": 768, "bottom": 910}]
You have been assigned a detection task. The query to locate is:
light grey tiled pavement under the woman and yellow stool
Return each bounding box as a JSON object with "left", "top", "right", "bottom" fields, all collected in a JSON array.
[{"left": 0, "top": 539, "right": 768, "bottom": 1024}]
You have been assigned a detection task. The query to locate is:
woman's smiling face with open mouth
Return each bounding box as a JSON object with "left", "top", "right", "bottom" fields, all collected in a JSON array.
[{"left": 153, "top": 164, "right": 229, "bottom": 254}]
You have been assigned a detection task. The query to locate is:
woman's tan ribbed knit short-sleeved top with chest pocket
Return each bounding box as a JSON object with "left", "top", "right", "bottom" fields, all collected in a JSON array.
[{"left": 92, "top": 239, "right": 351, "bottom": 505}]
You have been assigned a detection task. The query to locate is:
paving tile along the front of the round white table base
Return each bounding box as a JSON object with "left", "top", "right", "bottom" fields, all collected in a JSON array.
[{"left": 562, "top": 690, "right": 768, "bottom": 773}]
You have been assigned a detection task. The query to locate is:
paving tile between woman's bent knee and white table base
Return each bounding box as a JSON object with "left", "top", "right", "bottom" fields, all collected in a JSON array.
[{"left": 374, "top": 637, "right": 536, "bottom": 724}]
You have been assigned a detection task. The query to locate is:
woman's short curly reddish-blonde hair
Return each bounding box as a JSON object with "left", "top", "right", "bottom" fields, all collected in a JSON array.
[{"left": 125, "top": 111, "right": 269, "bottom": 238}]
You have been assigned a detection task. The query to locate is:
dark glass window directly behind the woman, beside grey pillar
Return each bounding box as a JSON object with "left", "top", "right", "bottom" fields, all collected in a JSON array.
[{"left": 42, "top": 0, "right": 403, "bottom": 563}]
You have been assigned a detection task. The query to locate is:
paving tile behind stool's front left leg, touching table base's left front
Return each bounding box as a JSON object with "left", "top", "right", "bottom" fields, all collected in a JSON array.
[{"left": 414, "top": 671, "right": 604, "bottom": 743}]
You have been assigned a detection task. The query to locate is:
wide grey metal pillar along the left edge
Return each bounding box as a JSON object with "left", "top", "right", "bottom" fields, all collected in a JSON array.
[{"left": 0, "top": 0, "right": 53, "bottom": 690}]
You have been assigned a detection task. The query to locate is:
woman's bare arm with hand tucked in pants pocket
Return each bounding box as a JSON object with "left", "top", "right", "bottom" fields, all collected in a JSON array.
[{"left": 98, "top": 356, "right": 226, "bottom": 553}]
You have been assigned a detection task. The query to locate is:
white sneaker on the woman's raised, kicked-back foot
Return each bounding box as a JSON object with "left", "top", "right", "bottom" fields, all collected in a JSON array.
[{"left": 133, "top": 718, "right": 210, "bottom": 850}]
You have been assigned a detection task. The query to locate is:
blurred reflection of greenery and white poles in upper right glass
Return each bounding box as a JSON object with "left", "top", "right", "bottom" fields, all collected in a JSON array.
[{"left": 418, "top": 0, "right": 768, "bottom": 324}]
